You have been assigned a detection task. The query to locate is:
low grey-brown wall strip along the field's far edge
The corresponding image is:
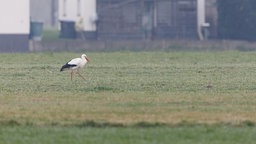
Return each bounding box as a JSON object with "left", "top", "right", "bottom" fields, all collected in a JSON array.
[{"left": 30, "top": 40, "right": 256, "bottom": 52}]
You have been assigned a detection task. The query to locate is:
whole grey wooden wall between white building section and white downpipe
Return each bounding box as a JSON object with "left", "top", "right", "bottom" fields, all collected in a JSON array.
[{"left": 97, "top": 0, "right": 198, "bottom": 39}]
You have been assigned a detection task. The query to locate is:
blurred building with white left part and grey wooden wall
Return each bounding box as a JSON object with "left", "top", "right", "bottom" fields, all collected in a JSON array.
[{"left": 58, "top": 0, "right": 210, "bottom": 40}]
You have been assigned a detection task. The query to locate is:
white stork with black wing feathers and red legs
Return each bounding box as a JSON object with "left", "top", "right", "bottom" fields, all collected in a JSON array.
[{"left": 60, "top": 54, "right": 89, "bottom": 80}]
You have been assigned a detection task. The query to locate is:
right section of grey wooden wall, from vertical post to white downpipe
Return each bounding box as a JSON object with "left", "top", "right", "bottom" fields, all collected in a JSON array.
[{"left": 155, "top": 0, "right": 198, "bottom": 39}]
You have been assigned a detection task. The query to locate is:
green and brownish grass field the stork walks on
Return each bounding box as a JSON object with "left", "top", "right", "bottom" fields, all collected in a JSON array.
[{"left": 0, "top": 51, "right": 256, "bottom": 144}]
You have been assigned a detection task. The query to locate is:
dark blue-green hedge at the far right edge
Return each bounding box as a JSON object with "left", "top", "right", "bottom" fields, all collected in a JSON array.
[{"left": 217, "top": 0, "right": 256, "bottom": 41}]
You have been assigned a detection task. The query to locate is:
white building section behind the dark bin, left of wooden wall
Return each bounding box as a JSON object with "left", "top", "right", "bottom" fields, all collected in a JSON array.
[{"left": 58, "top": 0, "right": 97, "bottom": 37}]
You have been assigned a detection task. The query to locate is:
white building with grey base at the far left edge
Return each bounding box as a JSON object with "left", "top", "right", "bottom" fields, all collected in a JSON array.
[{"left": 0, "top": 0, "right": 30, "bottom": 52}]
